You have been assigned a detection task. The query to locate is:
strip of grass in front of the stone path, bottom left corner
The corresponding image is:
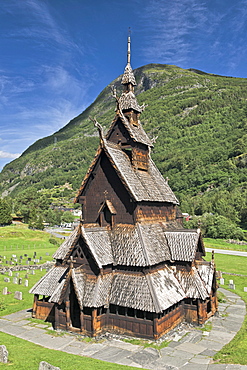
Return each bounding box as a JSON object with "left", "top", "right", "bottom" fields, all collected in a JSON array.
[{"left": 0, "top": 333, "right": 136, "bottom": 370}]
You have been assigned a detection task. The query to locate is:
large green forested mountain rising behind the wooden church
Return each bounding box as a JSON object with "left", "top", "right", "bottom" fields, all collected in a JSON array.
[{"left": 0, "top": 64, "right": 247, "bottom": 222}]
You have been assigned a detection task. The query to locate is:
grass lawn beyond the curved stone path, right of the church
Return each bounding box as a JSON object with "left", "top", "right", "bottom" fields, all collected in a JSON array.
[{"left": 206, "top": 253, "right": 247, "bottom": 365}]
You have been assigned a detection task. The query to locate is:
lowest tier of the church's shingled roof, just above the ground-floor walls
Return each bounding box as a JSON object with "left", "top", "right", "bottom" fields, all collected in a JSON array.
[{"left": 30, "top": 262, "right": 213, "bottom": 313}]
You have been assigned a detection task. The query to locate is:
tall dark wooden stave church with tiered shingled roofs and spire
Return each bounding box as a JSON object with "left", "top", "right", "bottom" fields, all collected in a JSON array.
[{"left": 30, "top": 38, "right": 217, "bottom": 339}]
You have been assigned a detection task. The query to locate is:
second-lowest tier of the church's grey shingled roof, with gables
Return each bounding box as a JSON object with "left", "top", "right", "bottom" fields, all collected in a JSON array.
[{"left": 51, "top": 222, "right": 203, "bottom": 268}]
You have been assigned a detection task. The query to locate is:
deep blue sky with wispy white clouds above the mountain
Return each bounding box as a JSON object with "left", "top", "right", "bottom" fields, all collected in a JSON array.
[{"left": 0, "top": 0, "right": 247, "bottom": 170}]
